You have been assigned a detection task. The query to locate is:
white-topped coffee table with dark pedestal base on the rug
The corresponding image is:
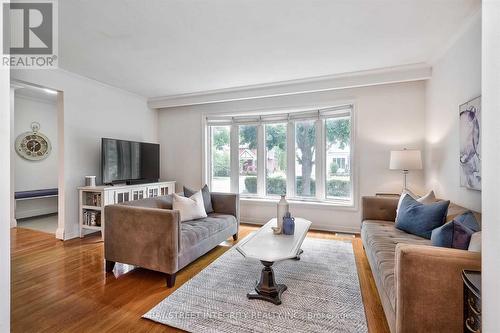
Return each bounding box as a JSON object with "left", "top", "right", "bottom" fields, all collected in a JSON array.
[{"left": 236, "top": 217, "right": 311, "bottom": 305}]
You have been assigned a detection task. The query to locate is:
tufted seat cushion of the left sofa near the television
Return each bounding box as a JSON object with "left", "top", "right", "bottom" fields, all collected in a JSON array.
[{"left": 181, "top": 213, "right": 237, "bottom": 251}]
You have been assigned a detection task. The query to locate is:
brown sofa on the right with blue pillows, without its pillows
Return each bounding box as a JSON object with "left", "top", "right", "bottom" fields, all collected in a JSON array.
[{"left": 361, "top": 197, "right": 481, "bottom": 333}]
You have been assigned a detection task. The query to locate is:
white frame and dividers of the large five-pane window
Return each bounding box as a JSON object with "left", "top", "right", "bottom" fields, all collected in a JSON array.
[{"left": 202, "top": 101, "right": 359, "bottom": 210}]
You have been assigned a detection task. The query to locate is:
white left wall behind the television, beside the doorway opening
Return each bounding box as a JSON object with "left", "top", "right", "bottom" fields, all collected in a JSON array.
[{"left": 12, "top": 70, "right": 158, "bottom": 239}]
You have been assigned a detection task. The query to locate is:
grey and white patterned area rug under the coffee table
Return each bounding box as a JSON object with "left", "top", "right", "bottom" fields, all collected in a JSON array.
[{"left": 143, "top": 238, "right": 368, "bottom": 333}]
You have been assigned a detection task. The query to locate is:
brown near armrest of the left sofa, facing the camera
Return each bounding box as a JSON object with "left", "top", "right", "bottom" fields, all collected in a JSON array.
[{"left": 104, "top": 205, "right": 180, "bottom": 274}]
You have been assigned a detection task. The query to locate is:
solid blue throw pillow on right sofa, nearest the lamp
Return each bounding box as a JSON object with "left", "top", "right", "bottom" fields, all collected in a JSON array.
[{"left": 396, "top": 195, "right": 450, "bottom": 239}]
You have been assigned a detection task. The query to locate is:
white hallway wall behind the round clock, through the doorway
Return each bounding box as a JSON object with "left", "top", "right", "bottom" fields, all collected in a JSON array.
[{"left": 12, "top": 93, "right": 58, "bottom": 218}]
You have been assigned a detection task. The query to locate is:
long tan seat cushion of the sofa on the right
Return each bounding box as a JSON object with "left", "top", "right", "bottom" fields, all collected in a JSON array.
[{"left": 361, "top": 220, "right": 431, "bottom": 311}]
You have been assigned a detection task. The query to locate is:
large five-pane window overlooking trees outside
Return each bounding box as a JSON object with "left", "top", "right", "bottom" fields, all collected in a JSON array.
[{"left": 206, "top": 105, "right": 353, "bottom": 205}]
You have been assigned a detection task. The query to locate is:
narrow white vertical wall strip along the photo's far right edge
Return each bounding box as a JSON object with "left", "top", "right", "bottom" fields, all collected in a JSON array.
[{"left": 481, "top": 0, "right": 500, "bottom": 333}]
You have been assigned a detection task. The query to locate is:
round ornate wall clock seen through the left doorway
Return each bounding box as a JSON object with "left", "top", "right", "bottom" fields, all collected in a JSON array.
[{"left": 16, "top": 122, "right": 52, "bottom": 161}]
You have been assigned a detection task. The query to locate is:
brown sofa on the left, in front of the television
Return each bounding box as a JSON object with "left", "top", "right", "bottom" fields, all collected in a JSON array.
[{"left": 104, "top": 193, "right": 240, "bottom": 287}]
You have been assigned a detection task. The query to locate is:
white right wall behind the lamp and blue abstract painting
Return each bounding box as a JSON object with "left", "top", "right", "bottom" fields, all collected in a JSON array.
[{"left": 425, "top": 15, "right": 481, "bottom": 211}]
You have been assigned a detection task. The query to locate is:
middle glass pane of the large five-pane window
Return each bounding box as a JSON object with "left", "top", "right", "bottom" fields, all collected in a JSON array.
[{"left": 264, "top": 123, "right": 287, "bottom": 196}]
